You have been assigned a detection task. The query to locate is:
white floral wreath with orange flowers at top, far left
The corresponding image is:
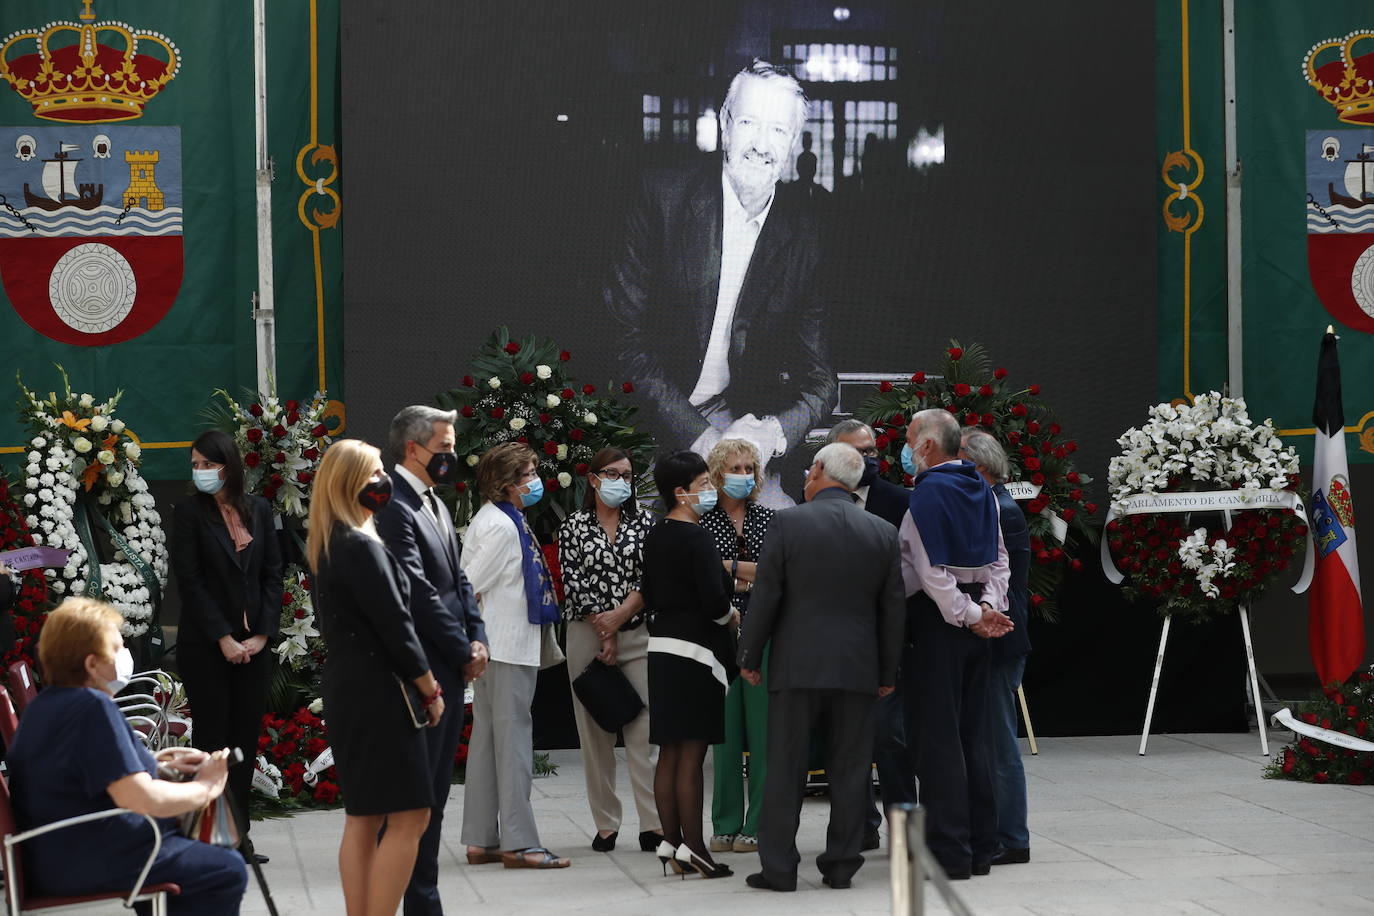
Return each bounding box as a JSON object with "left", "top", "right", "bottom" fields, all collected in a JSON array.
[{"left": 15, "top": 365, "right": 168, "bottom": 637}]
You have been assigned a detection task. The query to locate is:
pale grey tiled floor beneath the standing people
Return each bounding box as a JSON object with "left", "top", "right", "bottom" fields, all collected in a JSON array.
[{"left": 99, "top": 733, "right": 1374, "bottom": 916}]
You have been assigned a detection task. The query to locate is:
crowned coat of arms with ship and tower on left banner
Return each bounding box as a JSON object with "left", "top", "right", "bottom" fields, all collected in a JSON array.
[{"left": 0, "top": 3, "right": 183, "bottom": 346}]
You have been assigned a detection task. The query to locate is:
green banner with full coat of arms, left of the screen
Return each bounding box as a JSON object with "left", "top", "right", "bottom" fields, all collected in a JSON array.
[{"left": 0, "top": 0, "right": 344, "bottom": 479}]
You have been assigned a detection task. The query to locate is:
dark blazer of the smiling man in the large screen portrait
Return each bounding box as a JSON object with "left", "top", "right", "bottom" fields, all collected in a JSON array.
[{"left": 603, "top": 164, "right": 838, "bottom": 453}]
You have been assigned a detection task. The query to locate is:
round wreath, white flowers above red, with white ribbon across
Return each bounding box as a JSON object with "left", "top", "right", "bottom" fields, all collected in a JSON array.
[{"left": 1102, "top": 391, "right": 1308, "bottom": 622}]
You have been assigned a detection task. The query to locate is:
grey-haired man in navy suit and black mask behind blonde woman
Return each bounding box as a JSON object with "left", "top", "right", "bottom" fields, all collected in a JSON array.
[{"left": 375, "top": 405, "right": 488, "bottom": 916}]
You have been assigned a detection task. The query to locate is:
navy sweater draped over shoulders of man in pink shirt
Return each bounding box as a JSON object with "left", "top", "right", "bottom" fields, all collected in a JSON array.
[{"left": 910, "top": 461, "right": 998, "bottom": 569}]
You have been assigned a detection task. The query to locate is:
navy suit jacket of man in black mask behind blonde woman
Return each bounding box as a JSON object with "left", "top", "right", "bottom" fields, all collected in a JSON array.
[{"left": 374, "top": 474, "right": 486, "bottom": 673}]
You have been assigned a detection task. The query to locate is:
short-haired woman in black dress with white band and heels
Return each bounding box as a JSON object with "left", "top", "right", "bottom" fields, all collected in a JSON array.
[{"left": 643, "top": 452, "right": 739, "bottom": 878}]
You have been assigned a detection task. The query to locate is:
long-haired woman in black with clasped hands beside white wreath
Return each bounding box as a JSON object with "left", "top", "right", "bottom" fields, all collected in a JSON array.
[{"left": 170, "top": 430, "right": 282, "bottom": 862}]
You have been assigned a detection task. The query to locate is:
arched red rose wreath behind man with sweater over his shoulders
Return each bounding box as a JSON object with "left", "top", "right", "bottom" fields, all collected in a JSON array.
[{"left": 863, "top": 341, "right": 1098, "bottom": 621}]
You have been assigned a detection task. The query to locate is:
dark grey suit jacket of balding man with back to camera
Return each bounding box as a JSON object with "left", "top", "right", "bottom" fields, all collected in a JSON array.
[{"left": 739, "top": 486, "right": 905, "bottom": 696}]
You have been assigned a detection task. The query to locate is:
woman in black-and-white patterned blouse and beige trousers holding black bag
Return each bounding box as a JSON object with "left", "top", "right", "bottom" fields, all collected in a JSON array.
[{"left": 558, "top": 448, "right": 664, "bottom": 853}]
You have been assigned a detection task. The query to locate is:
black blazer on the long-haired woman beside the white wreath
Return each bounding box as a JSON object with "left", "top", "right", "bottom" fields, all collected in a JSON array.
[{"left": 170, "top": 496, "right": 282, "bottom": 645}]
